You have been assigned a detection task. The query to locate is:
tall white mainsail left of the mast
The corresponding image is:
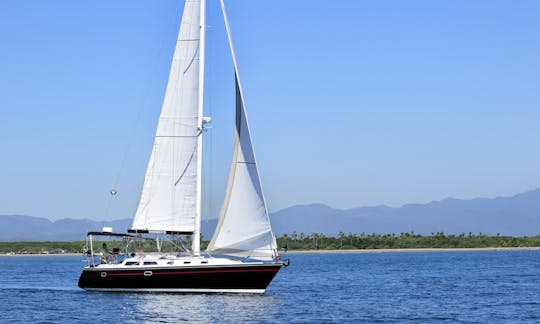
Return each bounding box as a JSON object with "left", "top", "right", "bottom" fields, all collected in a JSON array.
[{"left": 131, "top": 0, "right": 201, "bottom": 233}]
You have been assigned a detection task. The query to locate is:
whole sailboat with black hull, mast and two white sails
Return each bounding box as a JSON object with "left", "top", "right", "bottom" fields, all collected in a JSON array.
[{"left": 78, "top": 0, "right": 288, "bottom": 293}]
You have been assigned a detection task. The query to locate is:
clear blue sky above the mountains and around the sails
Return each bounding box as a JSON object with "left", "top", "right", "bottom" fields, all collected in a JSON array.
[{"left": 0, "top": 0, "right": 540, "bottom": 219}]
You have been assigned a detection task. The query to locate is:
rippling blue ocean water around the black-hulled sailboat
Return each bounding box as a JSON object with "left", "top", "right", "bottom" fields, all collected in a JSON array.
[{"left": 0, "top": 251, "right": 540, "bottom": 323}]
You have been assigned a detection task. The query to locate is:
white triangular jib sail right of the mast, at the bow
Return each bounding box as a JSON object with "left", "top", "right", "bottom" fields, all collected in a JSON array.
[{"left": 207, "top": 75, "right": 277, "bottom": 260}]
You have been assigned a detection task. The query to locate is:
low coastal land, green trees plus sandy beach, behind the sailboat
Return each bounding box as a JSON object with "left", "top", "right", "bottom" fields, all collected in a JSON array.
[{"left": 0, "top": 232, "right": 540, "bottom": 256}]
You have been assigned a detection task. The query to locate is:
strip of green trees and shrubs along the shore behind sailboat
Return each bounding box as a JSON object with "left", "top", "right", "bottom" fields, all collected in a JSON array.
[{"left": 0, "top": 232, "right": 540, "bottom": 254}]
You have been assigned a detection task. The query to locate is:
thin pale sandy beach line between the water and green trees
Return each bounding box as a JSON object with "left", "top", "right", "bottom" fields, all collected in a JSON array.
[{"left": 0, "top": 246, "right": 540, "bottom": 257}]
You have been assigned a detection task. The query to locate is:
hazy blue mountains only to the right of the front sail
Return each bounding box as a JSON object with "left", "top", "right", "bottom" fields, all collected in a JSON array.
[{"left": 272, "top": 189, "right": 540, "bottom": 236}]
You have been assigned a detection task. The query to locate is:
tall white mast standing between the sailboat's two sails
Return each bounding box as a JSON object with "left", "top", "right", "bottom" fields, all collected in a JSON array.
[{"left": 191, "top": 0, "right": 206, "bottom": 256}]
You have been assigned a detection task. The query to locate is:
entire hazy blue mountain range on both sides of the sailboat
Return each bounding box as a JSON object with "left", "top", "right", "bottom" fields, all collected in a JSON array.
[{"left": 0, "top": 189, "right": 540, "bottom": 241}]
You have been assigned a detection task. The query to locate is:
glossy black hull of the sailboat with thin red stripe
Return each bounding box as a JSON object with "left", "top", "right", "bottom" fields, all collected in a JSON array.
[{"left": 79, "top": 264, "right": 282, "bottom": 293}]
